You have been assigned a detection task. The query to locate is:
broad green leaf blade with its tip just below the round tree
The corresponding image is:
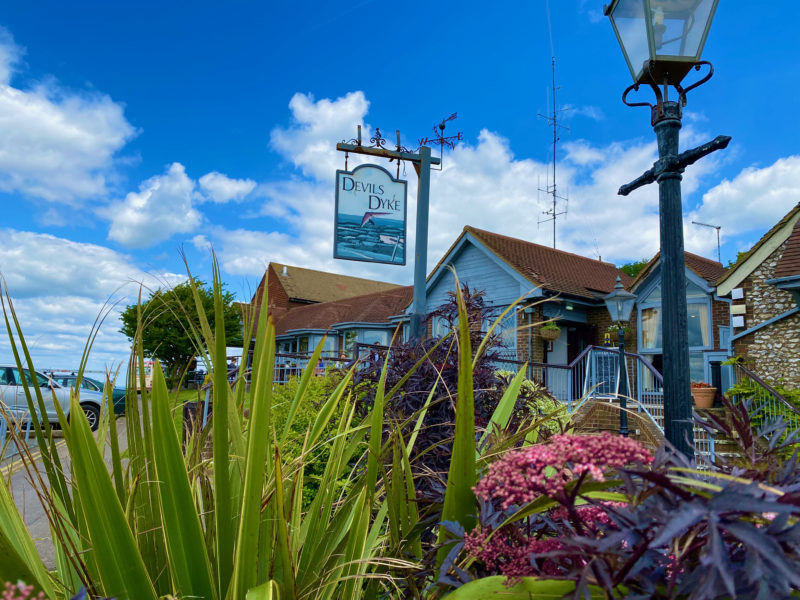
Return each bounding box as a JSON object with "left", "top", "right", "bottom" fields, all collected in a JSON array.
[{"left": 152, "top": 363, "right": 217, "bottom": 600}]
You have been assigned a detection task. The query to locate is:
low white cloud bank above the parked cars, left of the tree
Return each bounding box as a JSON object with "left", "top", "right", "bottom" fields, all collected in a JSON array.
[{"left": 0, "top": 229, "right": 185, "bottom": 376}]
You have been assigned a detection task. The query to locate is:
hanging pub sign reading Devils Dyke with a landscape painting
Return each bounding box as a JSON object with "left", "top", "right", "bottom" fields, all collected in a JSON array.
[{"left": 333, "top": 165, "right": 407, "bottom": 265}]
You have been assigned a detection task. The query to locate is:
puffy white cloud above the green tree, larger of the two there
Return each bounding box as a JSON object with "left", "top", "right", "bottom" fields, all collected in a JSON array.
[{"left": 104, "top": 163, "right": 202, "bottom": 248}]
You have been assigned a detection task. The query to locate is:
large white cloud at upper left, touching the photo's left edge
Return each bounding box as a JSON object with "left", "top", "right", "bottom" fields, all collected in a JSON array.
[{"left": 0, "top": 29, "right": 136, "bottom": 205}]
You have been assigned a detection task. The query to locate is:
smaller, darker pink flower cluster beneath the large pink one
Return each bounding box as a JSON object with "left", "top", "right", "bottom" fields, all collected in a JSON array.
[{"left": 464, "top": 526, "right": 565, "bottom": 585}]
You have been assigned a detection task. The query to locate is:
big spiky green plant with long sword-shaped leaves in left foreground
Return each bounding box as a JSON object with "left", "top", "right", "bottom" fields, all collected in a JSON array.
[{"left": 0, "top": 264, "right": 568, "bottom": 600}]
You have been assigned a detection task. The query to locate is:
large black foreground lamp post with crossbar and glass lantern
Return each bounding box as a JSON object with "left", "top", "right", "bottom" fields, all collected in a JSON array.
[{"left": 605, "top": 0, "right": 730, "bottom": 456}]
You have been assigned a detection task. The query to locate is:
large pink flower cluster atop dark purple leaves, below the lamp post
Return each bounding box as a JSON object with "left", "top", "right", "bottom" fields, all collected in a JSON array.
[{"left": 474, "top": 433, "right": 653, "bottom": 509}]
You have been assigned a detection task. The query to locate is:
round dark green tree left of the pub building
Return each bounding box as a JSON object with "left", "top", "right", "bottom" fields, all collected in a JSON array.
[{"left": 120, "top": 279, "right": 242, "bottom": 381}]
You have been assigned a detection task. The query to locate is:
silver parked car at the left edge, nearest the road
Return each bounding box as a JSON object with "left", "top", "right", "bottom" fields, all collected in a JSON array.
[{"left": 0, "top": 365, "right": 103, "bottom": 431}]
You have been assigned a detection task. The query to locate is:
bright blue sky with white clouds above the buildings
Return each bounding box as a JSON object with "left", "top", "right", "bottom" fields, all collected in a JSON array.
[{"left": 0, "top": 0, "right": 800, "bottom": 368}]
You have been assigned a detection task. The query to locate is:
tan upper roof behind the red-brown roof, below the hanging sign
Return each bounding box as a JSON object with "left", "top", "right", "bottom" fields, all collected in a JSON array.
[{"left": 270, "top": 263, "right": 400, "bottom": 302}]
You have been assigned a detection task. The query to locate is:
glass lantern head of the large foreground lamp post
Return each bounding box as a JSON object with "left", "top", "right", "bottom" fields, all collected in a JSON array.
[{"left": 606, "top": 0, "right": 718, "bottom": 84}]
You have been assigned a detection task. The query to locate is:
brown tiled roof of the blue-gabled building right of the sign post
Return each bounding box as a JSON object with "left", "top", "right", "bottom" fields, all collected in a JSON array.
[{"left": 464, "top": 226, "right": 633, "bottom": 299}]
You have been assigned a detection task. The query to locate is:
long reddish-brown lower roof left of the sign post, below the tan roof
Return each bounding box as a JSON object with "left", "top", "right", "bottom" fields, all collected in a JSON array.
[{"left": 275, "top": 286, "right": 414, "bottom": 335}]
